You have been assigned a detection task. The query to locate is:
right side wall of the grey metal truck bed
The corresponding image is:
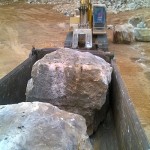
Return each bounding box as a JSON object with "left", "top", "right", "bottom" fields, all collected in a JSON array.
[{"left": 110, "top": 61, "right": 149, "bottom": 150}]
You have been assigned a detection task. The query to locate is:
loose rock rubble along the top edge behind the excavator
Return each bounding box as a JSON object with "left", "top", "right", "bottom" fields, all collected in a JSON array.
[{"left": 28, "top": 0, "right": 150, "bottom": 16}]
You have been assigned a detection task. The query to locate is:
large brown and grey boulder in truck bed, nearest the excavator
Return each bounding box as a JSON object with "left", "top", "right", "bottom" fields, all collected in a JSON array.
[{"left": 26, "top": 48, "right": 112, "bottom": 134}]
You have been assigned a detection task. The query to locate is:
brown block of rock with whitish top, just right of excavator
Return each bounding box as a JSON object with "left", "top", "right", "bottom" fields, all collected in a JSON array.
[{"left": 113, "top": 24, "right": 135, "bottom": 44}]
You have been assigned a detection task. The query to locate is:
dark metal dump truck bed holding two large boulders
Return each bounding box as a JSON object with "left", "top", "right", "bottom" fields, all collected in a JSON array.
[{"left": 0, "top": 48, "right": 150, "bottom": 150}]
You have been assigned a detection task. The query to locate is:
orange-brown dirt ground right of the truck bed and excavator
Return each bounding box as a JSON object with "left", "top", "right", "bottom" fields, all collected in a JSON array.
[{"left": 108, "top": 9, "right": 150, "bottom": 141}]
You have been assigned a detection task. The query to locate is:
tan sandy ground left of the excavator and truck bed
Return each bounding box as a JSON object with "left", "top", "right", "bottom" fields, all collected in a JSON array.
[{"left": 0, "top": 4, "right": 68, "bottom": 78}]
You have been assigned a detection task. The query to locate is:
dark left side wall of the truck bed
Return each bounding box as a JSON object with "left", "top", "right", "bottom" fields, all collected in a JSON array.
[{"left": 0, "top": 55, "right": 36, "bottom": 105}]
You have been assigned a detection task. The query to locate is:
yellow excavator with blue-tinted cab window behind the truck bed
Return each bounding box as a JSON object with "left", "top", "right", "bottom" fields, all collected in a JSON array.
[{"left": 64, "top": 0, "right": 108, "bottom": 51}]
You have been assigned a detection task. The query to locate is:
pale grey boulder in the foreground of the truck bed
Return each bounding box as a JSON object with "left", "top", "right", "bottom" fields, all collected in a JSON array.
[{"left": 0, "top": 102, "right": 92, "bottom": 150}]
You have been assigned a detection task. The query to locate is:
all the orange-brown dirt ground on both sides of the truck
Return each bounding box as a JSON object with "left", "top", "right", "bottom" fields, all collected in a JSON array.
[{"left": 0, "top": 4, "right": 150, "bottom": 140}]
